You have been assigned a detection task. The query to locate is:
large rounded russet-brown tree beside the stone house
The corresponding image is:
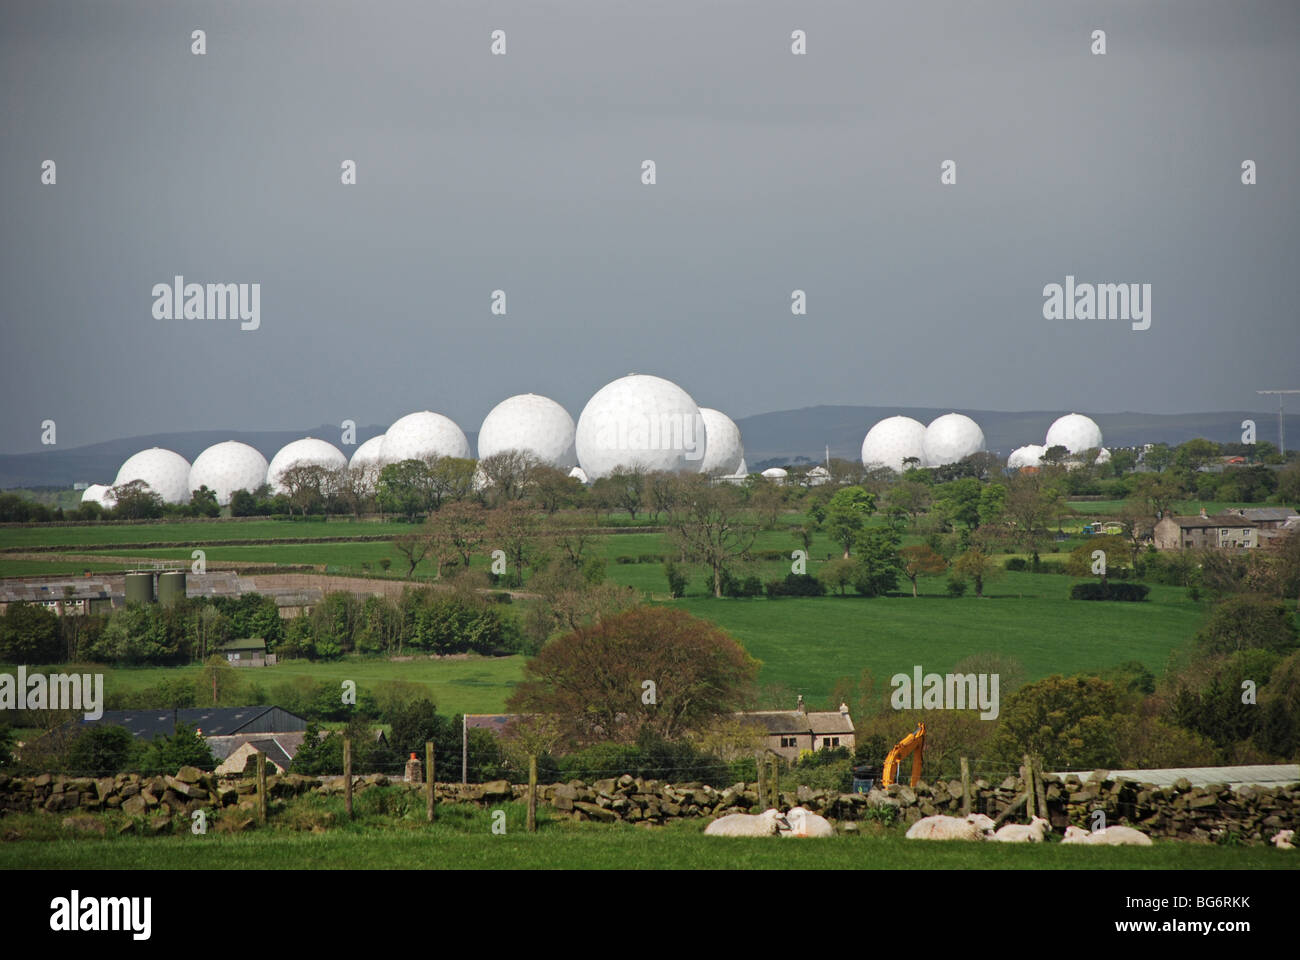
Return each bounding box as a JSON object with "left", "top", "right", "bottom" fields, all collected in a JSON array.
[{"left": 508, "top": 606, "right": 758, "bottom": 744}]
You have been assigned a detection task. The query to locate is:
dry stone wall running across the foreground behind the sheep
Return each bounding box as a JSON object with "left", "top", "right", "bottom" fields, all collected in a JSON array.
[{"left": 0, "top": 767, "right": 1300, "bottom": 843}]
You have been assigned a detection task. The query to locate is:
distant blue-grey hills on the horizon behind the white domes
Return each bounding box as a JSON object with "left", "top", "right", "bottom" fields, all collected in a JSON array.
[{"left": 0, "top": 406, "right": 1300, "bottom": 489}]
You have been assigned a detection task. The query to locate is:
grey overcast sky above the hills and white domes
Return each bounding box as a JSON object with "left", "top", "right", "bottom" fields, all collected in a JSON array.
[{"left": 0, "top": 0, "right": 1300, "bottom": 453}]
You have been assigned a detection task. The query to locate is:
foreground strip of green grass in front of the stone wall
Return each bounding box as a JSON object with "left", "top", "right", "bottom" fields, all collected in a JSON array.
[{"left": 0, "top": 795, "right": 1300, "bottom": 870}]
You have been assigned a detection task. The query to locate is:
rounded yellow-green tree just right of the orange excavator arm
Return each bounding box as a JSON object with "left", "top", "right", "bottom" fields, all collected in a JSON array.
[{"left": 992, "top": 674, "right": 1119, "bottom": 770}]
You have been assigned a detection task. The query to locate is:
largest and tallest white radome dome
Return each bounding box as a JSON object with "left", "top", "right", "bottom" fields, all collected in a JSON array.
[{"left": 575, "top": 373, "right": 707, "bottom": 480}]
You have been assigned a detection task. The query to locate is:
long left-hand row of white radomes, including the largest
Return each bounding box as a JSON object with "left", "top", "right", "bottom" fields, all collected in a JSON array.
[{"left": 82, "top": 373, "right": 748, "bottom": 507}]
